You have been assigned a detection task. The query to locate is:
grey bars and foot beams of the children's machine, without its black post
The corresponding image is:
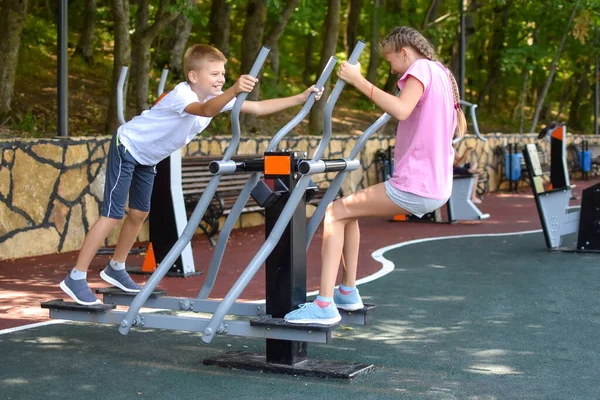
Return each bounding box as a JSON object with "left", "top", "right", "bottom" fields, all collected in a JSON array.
[{"left": 49, "top": 42, "right": 378, "bottom": 343}]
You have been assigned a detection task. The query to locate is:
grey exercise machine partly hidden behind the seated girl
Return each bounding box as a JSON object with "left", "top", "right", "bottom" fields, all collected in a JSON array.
[{"left": 384, "top": 100, "right": 490, "bottom": 223}]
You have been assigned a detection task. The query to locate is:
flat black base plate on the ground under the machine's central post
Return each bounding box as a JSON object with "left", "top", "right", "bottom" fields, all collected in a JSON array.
[{"left": 203, "top": 352, "right": 375, "bottom": 379}]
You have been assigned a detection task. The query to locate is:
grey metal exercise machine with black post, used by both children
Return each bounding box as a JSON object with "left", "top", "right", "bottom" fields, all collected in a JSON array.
[{"left": 42, "top": 42, "right": 389, "bottom": 378}]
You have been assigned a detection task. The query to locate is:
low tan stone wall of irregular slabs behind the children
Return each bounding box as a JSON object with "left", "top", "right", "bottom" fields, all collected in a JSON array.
[{"left": 0, "top": 134, "right": 600, "bottom": 260}]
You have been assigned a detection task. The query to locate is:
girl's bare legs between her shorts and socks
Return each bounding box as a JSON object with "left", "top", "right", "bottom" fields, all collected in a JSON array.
[{"left": 319, "top": 183, "right": 407, "bottom": 297}]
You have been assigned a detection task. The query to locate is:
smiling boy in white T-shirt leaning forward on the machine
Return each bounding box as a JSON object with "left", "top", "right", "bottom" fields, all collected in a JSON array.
[{"left": 60, "top": 44, "right": 321, "bottom": 305}]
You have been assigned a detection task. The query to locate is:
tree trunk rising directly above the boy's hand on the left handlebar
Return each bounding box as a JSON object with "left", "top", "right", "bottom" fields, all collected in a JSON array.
[{"left": 241, "top": 0, "right": 267, "bottom": 132}]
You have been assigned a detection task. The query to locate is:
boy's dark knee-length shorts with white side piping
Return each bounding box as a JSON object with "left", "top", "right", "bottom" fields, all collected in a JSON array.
[{"left": 101, "top": 134, "right": 156, "bottom": 219}]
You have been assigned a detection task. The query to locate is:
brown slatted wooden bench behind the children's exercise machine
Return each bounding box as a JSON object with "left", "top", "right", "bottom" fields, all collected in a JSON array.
[{"left": 181, "top": 154, "right": 336, "bottom": 246}]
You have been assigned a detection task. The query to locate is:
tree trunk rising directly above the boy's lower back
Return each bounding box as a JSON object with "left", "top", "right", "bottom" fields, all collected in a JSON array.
[{"left": 106, "top": 0, "right": 131, "bottom": 134}]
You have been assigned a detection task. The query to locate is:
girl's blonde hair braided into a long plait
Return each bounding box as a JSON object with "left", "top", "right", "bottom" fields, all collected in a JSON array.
[{"left": 381, "top": 26, "right": 467, "bottom": 138}]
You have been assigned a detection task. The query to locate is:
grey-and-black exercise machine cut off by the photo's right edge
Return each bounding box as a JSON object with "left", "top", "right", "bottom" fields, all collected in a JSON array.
[{"left": 523, "top": 144, "right": 600, "bottom": 253}]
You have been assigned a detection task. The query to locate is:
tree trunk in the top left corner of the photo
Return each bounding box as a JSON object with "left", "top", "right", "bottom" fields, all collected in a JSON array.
[{"left": 0, "top": 0, "right": 28, "bottom": 119}]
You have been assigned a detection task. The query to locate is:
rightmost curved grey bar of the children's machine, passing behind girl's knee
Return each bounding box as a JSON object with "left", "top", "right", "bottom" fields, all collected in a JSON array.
[{"left": 306, "top": 109, "right": 391, "bottom": 250}]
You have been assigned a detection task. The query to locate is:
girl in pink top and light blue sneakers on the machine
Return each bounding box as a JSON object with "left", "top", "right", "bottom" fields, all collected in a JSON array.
[{"left": 284, "top": 27, "right": 466, "bottom": 325}]
